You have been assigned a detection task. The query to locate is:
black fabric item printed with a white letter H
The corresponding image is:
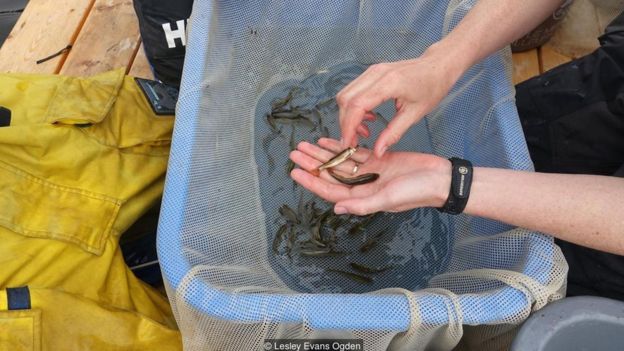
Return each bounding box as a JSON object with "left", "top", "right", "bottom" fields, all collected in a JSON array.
[{"left": 134, "top": 0, "right": 193, "bottom": 87}]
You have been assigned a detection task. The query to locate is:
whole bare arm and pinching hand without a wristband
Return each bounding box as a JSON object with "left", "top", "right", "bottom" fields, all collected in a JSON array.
[{"left": 336, "top": 0, "right": 561, "bottom": 157}]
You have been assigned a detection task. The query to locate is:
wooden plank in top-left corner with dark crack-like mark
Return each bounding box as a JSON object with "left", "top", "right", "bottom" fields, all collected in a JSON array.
[{"left": 0, "top": 0, "right": 94, "bottom": 73}]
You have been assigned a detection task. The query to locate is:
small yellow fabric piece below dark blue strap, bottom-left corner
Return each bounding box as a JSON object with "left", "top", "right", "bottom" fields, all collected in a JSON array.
[{"left": 0, "top": 309, "right": 41, "bottom": 351}]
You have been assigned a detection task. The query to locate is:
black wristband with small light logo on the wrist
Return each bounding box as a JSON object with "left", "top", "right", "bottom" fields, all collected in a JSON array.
[{"left": 438, "top": 157, "right": 472, "bottom": 214}]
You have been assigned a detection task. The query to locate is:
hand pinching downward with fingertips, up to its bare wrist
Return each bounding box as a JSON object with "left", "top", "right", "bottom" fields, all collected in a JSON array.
[{"left": 336, "top": 46, "right": 463, "bottom": 158}]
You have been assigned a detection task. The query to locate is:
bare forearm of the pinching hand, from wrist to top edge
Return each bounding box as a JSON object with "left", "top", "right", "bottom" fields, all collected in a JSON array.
[{"left": 428, "top": 0, "right": 562, "bottom": 74}]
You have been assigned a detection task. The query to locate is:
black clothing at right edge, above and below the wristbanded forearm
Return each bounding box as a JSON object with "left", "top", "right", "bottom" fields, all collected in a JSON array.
[{"left": 516, "top": 13, "right": 624, "bottom": 300}]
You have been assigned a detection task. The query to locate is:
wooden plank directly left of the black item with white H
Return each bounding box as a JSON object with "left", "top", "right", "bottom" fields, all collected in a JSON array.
[{"left": 61, "top": 0, "right": 140, "bottom": 76}]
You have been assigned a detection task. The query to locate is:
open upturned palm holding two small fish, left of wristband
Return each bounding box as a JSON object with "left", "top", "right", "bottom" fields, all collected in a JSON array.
[{"left": 290, "top": 138, "right": 451, "bottom": 215}]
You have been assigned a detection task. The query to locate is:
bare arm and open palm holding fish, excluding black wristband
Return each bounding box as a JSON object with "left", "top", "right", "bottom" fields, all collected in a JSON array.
[{"left": 291, "top": 139, "right": 624, "bottom": 255}]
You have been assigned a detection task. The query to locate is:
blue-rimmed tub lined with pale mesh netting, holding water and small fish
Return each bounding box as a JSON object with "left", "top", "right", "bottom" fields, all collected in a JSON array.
[{"left": 159, "top": 0, "right": 567, "bottom": 350}]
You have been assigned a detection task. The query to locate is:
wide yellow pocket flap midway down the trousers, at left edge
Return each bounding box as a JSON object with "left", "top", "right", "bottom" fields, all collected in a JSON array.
[{"left": 0, "top": 161, "right": 121, "bottom": 255}]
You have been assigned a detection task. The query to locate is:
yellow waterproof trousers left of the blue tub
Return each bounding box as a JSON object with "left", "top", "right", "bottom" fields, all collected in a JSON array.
[{"left": 0, "top": 70, "right": 181, "bottom": 351}]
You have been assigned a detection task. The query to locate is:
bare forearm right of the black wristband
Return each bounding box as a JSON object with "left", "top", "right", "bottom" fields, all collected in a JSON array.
[{"left": 465, "top": 168, "right": 624, "bottom": 254}]
